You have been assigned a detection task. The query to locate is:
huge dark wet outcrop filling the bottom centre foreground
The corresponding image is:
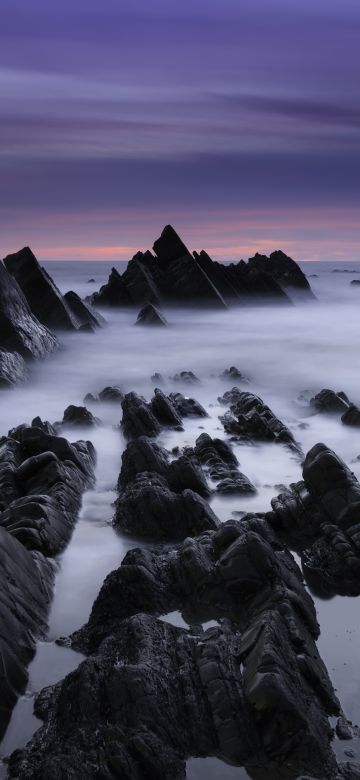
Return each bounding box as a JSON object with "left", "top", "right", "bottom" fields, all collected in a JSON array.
[{"left": 16, "top": 517, "right": 339, "bottom": 780}]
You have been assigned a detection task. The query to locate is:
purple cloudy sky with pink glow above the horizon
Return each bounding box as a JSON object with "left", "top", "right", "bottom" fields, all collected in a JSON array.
[{"left": 0, "top": 0, "right": 360, "bottom": 261}]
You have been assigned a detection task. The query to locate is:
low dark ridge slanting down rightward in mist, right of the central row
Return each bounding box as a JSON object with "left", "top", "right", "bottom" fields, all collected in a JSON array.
[{"left": 219, "top": 388, "right": 301, "bottom": 455}]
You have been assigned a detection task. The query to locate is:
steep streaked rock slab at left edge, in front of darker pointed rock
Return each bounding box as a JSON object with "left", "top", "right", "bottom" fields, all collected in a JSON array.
[{"left": 0, "top": 263, "right": 58, "bottom": 358}]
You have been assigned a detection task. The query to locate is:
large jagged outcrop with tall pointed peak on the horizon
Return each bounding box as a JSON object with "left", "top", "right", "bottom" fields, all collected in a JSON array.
[{"left": 90, "top": 225, "right": 304, "bottom": 309}]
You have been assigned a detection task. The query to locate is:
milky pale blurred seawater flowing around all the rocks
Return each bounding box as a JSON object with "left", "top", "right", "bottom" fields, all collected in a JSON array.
[{"left": 0, "top": 262, "right": 360, "bottom": 780}]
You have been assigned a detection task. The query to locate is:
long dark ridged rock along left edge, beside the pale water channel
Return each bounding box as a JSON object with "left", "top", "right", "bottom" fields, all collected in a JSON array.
[{"left": 0, "top": 425, "right": 95, "bottom": 736}]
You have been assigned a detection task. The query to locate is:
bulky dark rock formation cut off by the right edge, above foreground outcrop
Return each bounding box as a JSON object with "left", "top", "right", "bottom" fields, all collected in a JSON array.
[{"left": 267, "top": 444, "right": 360, "bottom": 596}]
